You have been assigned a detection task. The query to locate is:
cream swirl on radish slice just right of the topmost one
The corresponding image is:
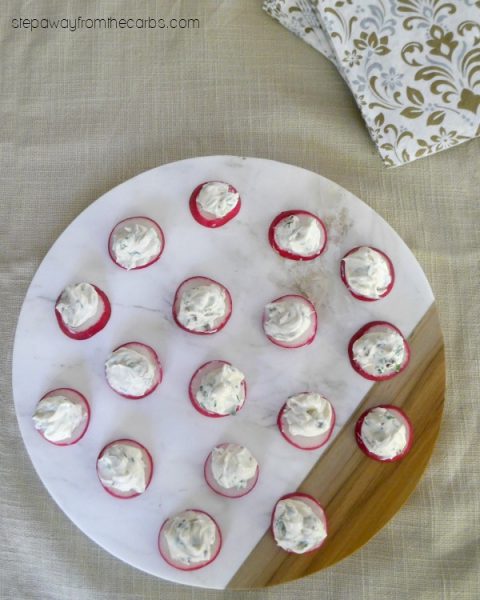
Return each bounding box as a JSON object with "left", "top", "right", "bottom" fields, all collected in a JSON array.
[{"left": 275, "top": 215, "right": 324, "bottom": 256}]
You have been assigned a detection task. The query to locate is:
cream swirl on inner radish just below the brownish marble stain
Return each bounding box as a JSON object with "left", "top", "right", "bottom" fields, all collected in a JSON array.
[{"left": 264, "top": 298, "right": 313, "bottom": 343}]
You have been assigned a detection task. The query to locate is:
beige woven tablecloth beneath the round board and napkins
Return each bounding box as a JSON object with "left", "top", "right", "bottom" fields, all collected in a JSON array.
[{"left": 0, "top": 0, "right": 480, "bottom": 600}]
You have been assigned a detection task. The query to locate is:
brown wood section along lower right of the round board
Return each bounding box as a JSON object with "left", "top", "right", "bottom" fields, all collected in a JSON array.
[{"left": 228, "top": 305, "right": 445, "bottom": 588}]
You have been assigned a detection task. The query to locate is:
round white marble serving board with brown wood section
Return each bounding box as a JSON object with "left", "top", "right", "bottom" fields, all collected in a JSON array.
[{"left": 13, "top": 156, "right": 444, "bottom": 588}]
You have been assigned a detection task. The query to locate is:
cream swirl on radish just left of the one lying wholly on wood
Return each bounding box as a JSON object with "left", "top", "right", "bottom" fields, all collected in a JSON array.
[{"left": 284, "top": 392, "right": 333, "bottom": 437}]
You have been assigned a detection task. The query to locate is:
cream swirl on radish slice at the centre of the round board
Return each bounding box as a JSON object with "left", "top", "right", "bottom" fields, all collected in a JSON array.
[{"left": 195, "top": 365, "right": 245, "bottom": 415}]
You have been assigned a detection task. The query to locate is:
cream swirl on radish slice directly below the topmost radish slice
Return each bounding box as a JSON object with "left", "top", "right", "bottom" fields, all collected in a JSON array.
[{"left": 177, "top": 283, "right": 228, "bottom": 332}]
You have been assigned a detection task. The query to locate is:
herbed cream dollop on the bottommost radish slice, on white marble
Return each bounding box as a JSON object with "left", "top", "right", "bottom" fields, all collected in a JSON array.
[{"left": 164, "top": 510, "right": 217, "bottom": 566}]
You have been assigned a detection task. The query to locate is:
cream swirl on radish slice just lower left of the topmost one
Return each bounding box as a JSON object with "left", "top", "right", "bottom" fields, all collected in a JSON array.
[{"left": 112, "top": 222, "right": 162, "bottom": 270}]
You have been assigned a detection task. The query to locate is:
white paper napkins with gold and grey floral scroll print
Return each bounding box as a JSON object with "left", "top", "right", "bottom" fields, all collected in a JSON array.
[{"left": 264, "top": 0, "right": 480, "bottom": 166}]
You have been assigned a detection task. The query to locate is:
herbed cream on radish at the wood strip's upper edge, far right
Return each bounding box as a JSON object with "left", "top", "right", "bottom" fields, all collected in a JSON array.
[{"left": 352, "top": 328, "right": 405, "bottom": 377}]
